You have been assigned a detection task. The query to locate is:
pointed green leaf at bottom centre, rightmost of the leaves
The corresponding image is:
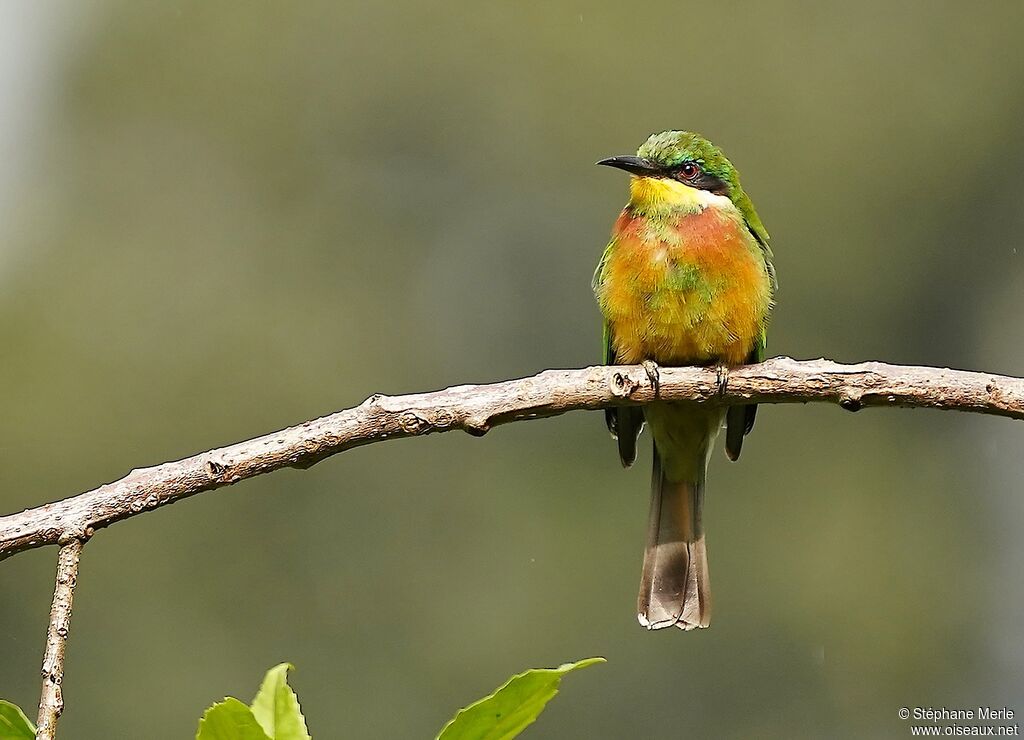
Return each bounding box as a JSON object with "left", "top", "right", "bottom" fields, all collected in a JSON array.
[{"left": 437, "top": 658, "right": 604, "bottom": 740}]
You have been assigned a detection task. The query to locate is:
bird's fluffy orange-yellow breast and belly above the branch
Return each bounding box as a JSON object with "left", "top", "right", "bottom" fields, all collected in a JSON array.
[{"left": 598, "top": 208, "right": 771, "bottom": 364}]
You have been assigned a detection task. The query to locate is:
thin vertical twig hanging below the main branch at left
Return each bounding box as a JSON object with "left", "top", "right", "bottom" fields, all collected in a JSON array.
[{"left": 36, "top": 539, "right": 82, "bottom": 740}]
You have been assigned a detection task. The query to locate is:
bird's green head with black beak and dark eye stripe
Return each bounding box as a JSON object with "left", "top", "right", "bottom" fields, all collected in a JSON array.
[{"left": 597, "top": 131, "right": 768, "bottom": 244}]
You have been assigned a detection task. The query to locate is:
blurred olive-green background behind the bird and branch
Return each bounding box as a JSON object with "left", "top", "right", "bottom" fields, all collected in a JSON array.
[{"left": 0, "top": 0, "right": 1024, "bottom": 739}]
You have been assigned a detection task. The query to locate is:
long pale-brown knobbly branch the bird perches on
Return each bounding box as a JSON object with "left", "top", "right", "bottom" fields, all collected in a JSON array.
[{"left": 0, "top": 357, "right": 1024, "bottom": 560}]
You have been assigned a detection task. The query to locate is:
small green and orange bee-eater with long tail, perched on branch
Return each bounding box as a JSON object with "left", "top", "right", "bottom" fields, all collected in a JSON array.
[{"left": 594, "top": 131, "right": 776, "bottom": 629}]
